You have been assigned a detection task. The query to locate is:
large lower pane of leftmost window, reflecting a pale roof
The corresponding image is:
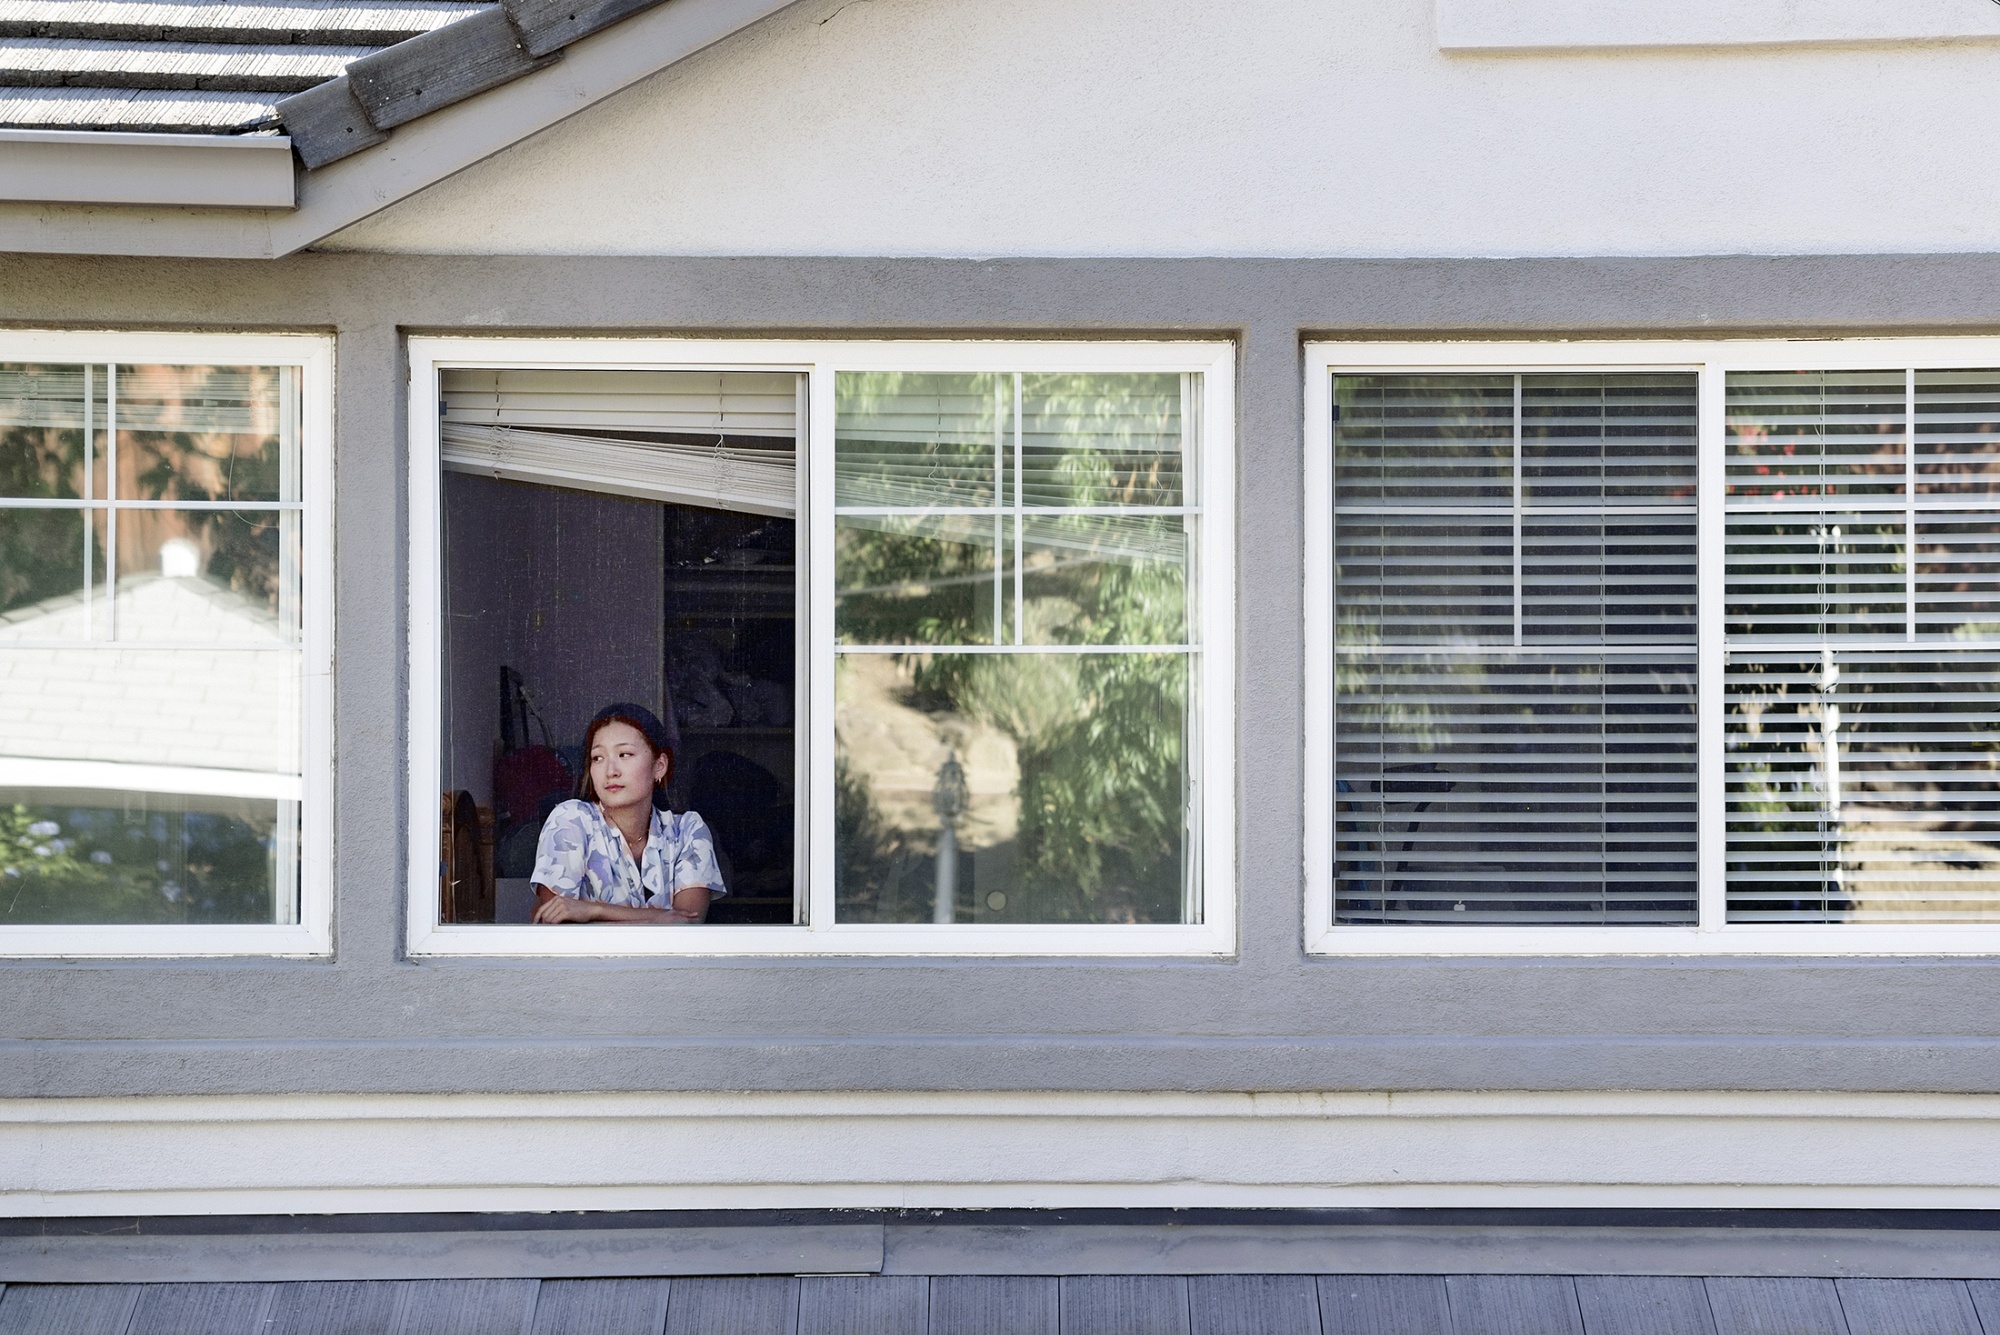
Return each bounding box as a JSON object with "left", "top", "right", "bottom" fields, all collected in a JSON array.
[{"left": 0, "top": 646, "right": 300, "bottom": 923}]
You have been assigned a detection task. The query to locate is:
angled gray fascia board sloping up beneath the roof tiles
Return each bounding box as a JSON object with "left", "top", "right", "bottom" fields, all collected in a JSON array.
[{"left": 0, "top": 0, "right": 794, "bottom": 260}]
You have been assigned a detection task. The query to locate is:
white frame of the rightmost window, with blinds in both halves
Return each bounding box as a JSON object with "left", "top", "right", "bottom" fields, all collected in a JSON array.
[{"left": 1304, "top": 338, "right": 2000, "bottom": 955}]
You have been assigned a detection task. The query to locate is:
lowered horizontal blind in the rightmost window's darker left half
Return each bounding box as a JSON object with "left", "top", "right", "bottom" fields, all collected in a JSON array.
[{"left": 1334, "top": 374, "right": 1696, "bottom": 923}]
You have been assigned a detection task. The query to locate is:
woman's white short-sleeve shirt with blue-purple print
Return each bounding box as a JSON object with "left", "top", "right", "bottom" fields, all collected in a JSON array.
[{"left": 532, "top": 799, "right": 730, "bottom": 909}]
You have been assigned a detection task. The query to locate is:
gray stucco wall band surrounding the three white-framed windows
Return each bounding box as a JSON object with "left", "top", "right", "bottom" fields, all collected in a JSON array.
[{"left": 0, "top": 256, "right": 2000, "bottom": 1095}]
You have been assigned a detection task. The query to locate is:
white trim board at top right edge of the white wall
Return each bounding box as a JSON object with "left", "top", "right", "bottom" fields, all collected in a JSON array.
[{"left": 1438, "top": 0, "right": 2000, "bottom": 52}]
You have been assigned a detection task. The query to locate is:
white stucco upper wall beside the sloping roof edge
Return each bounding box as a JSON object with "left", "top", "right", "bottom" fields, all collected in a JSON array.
[{"left": 316, "top": 0, "right": 2000, "bottom": 256}]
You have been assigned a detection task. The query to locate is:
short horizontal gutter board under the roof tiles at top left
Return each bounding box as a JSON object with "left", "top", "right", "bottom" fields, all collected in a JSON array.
[{"left": 0, "top": 130, "right": 294, "bottom": 208}]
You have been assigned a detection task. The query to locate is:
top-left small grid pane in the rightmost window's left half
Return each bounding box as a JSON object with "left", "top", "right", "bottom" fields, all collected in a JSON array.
[{"left": 1334, "top": 376, "right": 1514, "bottom": 506}]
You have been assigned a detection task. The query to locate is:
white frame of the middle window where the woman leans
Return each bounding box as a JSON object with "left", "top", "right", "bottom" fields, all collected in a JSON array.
[{"left": 406, "top": 338, "right": 1236, "bottom": 957}]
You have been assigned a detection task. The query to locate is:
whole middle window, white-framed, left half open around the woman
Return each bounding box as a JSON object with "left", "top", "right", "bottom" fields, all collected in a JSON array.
[{"left": 412, "top": 340, "right": 1234, "bottom": 953}]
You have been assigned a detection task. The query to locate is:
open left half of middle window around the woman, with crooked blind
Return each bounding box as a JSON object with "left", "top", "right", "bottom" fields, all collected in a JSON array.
[{"left": 438, "top": 368, "right": 804, "bottom": 923}]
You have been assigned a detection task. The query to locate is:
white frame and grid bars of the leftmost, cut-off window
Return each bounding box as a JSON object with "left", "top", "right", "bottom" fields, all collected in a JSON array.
[{"left": 0, "top": 330, "right": 334, "bottom": 957}]
